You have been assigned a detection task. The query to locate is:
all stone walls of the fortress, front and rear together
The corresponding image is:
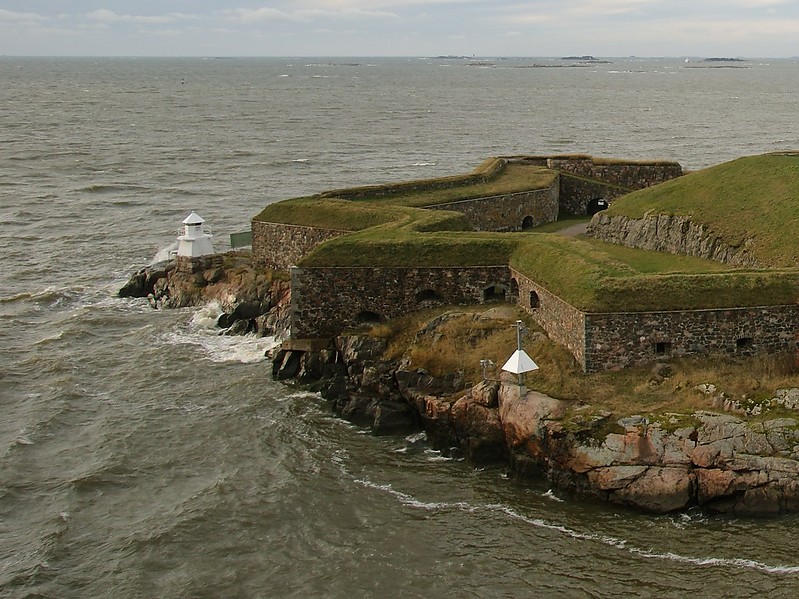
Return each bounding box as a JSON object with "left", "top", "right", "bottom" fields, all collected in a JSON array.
[{"left": 253, "top": 157, "right": 799, "bottom": 372}]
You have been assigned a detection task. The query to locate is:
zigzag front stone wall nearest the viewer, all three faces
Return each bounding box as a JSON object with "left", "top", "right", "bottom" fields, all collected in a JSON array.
[{"left": 291, "top": 266, "right": 799, "bottom": 372}]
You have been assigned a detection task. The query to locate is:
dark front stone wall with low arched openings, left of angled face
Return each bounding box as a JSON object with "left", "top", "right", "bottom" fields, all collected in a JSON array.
[{"left": 291, "top": 266, "right": 510, "bottom": 338}]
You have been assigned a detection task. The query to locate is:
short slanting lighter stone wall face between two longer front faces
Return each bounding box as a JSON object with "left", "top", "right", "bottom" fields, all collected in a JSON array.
[{"left": 511, "top": 269, "right": 585, "bottom": 367}]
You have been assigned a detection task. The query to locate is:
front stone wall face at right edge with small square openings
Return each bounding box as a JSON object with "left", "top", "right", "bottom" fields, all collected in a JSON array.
[{"left": 585, "top": 305, "right": 799, "bottom": 372}]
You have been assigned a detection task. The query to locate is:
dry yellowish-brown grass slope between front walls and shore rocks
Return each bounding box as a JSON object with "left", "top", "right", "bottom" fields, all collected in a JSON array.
[{"left": 370, "top": 305, "right": 799, "bottom": 427}]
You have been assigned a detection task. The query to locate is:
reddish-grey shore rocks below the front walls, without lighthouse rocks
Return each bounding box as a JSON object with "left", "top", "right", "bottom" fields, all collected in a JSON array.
[{"left": 273, "top": 336, "right": 799, "bottom": 516}]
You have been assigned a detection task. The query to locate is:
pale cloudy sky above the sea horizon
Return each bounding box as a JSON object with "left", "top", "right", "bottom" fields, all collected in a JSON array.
[{"left": 0, "top": 0, "right": 799, "bottom": 58}]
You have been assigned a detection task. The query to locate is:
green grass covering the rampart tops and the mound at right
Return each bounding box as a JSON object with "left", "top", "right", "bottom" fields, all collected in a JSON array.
[{"left": 255, "top": 155, "right": 799, "bottom": 312}]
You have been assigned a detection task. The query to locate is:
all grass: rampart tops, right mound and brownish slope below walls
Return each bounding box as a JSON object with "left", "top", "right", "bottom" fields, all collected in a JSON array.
[{"left": 258, "top": 156, "right": 799, "bottom": 415}]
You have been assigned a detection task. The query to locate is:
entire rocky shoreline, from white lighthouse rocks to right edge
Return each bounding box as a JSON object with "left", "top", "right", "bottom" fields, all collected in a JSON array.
[{"left": 119, "top": 254, "right": 799, "bottom": 516}]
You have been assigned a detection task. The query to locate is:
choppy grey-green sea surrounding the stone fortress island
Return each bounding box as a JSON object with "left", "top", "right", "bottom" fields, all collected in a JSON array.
[{"left": 0, "top": 56, "right": 799, "bottom": 599}]
